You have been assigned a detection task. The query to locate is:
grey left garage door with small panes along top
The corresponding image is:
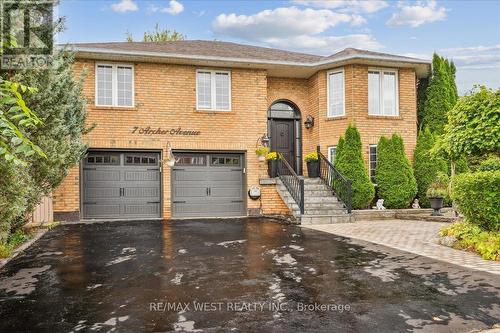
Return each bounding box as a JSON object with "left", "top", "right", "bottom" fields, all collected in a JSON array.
[{"left": 82, "top": 151, "right": 161, "bottom": 219}]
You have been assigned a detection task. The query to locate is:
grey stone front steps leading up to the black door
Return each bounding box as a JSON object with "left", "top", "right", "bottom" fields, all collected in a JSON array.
[{"left": 277, "top": 178, "right": 351, "bottom": 224}]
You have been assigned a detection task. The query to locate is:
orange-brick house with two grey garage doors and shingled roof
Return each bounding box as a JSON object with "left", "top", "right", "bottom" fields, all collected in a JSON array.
[{"left": 53, "top": 41, "right": 430, "bottom": 220}]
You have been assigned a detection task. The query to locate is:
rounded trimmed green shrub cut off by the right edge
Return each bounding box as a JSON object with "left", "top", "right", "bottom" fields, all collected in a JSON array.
[{"left": 451, "top": 171, "right": 500, "bottom": 232}]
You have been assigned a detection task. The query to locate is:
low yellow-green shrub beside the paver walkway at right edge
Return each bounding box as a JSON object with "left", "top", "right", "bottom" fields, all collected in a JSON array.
[{"left": 439, "top": 222, "right": 500, "bottom": 260}]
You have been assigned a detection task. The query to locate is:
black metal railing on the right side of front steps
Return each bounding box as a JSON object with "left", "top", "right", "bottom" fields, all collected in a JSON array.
[{"left": 317, "top": 146, "right": 352, "bottom": 213}]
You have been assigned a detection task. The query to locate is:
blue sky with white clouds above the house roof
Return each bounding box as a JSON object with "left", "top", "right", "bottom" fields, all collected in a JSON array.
[{"left": 58, "top": 0, "right": 500, "bottom": 94}]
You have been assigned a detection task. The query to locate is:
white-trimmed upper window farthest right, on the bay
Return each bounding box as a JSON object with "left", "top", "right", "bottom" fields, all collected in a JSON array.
[{"left": 368, "top": 70, "right": 398, "bottom": 116}]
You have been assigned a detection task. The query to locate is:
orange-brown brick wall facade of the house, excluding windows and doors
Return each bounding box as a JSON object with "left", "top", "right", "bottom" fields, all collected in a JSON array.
[{"left": 54, "top": 60, "right": 417, "bottom": 218}]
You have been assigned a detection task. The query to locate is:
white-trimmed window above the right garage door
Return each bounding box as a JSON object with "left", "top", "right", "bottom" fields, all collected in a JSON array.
[{"left": 196, "top": 70, "right": 231, "bottom": 111}]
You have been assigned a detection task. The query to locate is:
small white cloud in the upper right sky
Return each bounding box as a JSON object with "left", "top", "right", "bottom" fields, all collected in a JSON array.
[{"left": 387, "top": 0, "right": 446, "bottom": 28}]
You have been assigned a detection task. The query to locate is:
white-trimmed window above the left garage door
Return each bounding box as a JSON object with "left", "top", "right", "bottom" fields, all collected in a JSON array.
[{"left": 95, "top": 64, "right": 134, "bottom": 107}]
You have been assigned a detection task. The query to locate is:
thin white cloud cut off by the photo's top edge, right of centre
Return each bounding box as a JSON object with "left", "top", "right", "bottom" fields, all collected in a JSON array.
[{"left": 292, "top": 0, "right": 389, "bottom": 14}]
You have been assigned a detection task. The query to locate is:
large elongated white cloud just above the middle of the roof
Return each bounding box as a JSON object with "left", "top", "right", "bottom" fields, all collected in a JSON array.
[{"left": 212, "top": 7, "right": 364, "bottom": 40}]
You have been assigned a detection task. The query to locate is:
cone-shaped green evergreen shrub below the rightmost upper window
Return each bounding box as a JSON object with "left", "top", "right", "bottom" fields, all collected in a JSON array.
[{"left": 375, "top": 134, "right": 417, "bottom": 208}]
